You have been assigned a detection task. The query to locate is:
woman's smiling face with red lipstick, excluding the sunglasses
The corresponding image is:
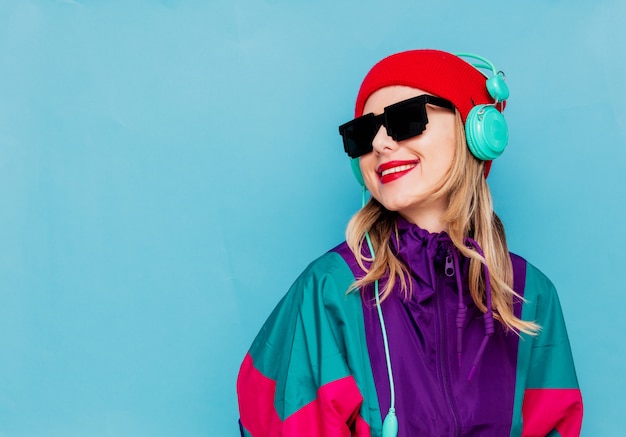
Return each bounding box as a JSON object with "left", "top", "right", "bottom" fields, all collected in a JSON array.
[{"left": 359, "top": 86, "right": 456, "bottom": 225}]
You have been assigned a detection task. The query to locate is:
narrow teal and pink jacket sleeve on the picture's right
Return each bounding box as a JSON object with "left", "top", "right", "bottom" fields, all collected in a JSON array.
[{"left": 522, "top": 266, "right": 583, "bottom": 437}]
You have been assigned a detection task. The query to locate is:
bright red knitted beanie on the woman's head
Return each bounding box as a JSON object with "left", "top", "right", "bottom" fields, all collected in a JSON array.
[{"left": 354, "top": 50, "right": 502, "bottom": 177}]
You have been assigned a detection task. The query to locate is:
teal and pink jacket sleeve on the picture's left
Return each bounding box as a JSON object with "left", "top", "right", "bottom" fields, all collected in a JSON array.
[{"left": 237, "top": 252, "right": 370, "bottom": 437}]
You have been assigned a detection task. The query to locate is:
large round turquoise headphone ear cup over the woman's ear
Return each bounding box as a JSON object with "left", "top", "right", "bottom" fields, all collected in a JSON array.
[{"left": 465, "top": 105, "right": 509, "bottom": 161}]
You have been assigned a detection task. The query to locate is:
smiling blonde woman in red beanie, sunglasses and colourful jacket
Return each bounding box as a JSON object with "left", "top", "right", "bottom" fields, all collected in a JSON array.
[{"left": 237, "top": 50, "right": 582, "bottom": 437}]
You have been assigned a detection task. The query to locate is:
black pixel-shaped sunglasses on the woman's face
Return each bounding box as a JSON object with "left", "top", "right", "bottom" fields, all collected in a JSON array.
[{"left": 339, "top": 94, "right": 454, "bottom": 158}]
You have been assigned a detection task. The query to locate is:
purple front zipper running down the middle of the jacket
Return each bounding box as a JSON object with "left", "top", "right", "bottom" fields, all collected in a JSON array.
[{"left": 435, "top": 251, "right": 459, "bottom": 436}]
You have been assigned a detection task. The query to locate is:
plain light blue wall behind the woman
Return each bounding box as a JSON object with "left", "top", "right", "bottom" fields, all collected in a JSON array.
[{"left": 0, "top": 0, "right": 626, "bottom": 437}]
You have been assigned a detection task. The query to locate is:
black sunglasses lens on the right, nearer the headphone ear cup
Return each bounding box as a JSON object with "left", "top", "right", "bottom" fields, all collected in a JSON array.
[{"left": 385, "top": 99, "right": 428, "bottom": 141}]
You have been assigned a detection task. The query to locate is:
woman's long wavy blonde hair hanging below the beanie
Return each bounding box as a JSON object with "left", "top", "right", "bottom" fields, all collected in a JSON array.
[{"left": 346, "top": 111, "right": 540, "bottom": 335}]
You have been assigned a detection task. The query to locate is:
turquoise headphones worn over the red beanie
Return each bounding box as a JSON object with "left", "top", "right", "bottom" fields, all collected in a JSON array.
[{"left": 350, "top": 53, "right": 509, "bottom": 186}]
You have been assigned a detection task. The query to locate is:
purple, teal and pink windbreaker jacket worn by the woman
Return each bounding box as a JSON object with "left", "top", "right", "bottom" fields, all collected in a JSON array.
[{"left": 237, "top": 217, "right": 583, "bottom": 437}]
